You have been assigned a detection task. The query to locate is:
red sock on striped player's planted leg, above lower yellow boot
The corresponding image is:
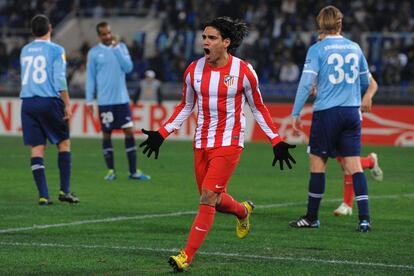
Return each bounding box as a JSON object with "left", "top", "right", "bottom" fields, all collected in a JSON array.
[{"left": 184, "top": 204, "right": 216, "bottom": 263}]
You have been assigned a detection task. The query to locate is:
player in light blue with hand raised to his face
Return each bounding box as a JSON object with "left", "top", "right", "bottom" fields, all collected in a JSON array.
[{"left": 85, "top": 22, "right": 151, "bottom": 181}]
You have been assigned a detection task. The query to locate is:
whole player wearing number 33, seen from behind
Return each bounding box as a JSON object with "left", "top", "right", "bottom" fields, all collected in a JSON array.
[{"left": 289, "top": 6, "right": 371, "bottom": 232}]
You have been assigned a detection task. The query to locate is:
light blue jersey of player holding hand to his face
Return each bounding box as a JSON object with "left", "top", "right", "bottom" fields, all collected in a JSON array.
[{"left": 85, "top": 43, "right": 133, "bottom": 105}]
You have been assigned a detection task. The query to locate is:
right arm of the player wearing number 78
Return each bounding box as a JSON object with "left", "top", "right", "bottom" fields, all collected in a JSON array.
[{"left": 53, "top": 48, "right": 72, "bottom": 120}]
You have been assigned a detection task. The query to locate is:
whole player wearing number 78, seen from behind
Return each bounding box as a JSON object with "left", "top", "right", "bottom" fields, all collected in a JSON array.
[{"left": 20, "top": 15, "right": 79, "bottom": 205}]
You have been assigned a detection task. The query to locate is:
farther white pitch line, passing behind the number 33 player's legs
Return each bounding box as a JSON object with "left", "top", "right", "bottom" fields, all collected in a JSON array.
[{"left": 0, "top": 193, "right": 414, "bottom": 234}]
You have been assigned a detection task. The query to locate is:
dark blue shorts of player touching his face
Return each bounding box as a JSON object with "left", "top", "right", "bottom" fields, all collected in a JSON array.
[{"left": 98, "top": 103, "right": 134, "bottom": 132}]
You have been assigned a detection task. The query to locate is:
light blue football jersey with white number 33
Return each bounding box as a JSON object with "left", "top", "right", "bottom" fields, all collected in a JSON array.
[{"left": 292, "top": 36, "right": 370, "bottom": 118}]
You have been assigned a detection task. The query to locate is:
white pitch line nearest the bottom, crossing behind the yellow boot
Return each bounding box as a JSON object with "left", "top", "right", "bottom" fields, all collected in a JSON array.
[{"left": 0, "top": 242, "right": 414, "bottom": 270}]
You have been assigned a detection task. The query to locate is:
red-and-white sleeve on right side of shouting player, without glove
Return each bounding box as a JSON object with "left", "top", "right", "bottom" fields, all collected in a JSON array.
[{"left": 243, "top": 64, "right": 282, "bottom": 146}]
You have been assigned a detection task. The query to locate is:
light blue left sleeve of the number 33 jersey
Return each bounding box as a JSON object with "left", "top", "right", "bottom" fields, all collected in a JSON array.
[{"left": 292, "top": 47, "right": 319, "bottom": 118}]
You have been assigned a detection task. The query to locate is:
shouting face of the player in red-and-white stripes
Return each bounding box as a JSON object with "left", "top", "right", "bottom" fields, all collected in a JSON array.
[{"left": 203, "top": 26, "right": 230, "bottom": 65}]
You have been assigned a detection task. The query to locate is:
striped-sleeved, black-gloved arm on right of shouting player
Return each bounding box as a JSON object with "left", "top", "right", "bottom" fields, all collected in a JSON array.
[{"left": 243, "top": 65, "right": 296, "bottom": 170}]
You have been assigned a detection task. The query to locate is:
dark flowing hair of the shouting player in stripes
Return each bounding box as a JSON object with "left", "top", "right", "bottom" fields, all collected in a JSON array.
[{"left": 204, "top": 16, "right": 247, "bottom": 53}]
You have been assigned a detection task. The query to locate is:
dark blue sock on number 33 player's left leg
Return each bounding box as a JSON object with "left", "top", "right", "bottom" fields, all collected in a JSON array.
[{"left": 306, "top": 173, "right": 325, "bottom": 220}]
